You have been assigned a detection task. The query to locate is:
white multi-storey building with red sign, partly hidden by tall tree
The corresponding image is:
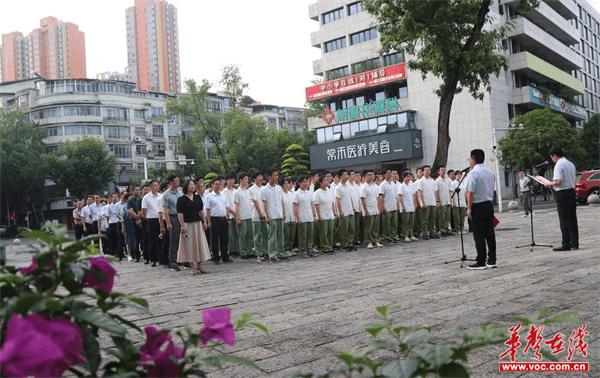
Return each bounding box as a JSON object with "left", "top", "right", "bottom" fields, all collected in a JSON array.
[{"left": 306, "top": 0, "right": 600, "bottom": 198}]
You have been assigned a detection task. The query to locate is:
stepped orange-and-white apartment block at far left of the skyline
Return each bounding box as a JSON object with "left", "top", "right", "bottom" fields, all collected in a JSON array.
[{"left": 0, "top": 17, "right": 87, "bottom": 81}]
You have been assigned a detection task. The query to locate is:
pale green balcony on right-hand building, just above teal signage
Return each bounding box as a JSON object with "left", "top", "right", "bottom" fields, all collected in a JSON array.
[{"left": 508, "top": 52, "right": 585, "bottom": 94}]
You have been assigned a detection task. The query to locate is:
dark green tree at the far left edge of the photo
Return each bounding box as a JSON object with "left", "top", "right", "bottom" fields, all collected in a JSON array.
[{"left": 0, "top": 111, "right": 46, "bottom": 224}]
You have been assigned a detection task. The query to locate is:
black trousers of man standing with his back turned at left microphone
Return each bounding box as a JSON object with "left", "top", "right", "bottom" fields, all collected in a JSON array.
[{"left": 471, "top": 201, "right": 496, "bottom": 265}]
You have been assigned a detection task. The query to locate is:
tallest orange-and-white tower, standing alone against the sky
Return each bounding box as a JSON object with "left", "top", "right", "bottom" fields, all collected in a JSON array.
[{"left": 125, "top": 0, "right": 181, "bottom": 93}]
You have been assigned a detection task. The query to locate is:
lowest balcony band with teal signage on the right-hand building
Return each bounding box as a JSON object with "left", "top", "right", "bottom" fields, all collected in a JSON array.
[{"left": 513, "top": 86, "right": 587, "bottom": 121}]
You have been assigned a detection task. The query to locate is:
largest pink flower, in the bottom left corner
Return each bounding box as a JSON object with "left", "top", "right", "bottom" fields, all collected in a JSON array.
[{"left": 0, "top": 314, "right": 84, "bottom": 377}]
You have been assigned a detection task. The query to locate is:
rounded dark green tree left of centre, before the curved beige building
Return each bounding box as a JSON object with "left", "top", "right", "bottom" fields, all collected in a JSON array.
[{"left": 47, "top": 137, "right": 117, "bottom": 198}]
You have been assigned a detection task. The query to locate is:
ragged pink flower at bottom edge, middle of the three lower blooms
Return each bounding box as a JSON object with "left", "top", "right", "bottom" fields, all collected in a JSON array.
[{"left": 140, "top": 326, "right": 184, "bottom": 377}]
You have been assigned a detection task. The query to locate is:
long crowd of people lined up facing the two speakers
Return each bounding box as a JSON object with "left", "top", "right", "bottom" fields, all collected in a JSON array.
[{"left": 73, "top": 166, "right": 468, "bottom": 274}]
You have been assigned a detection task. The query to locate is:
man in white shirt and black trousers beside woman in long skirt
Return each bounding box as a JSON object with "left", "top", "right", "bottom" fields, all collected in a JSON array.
[{"left": 205, "top": 177, "right": 233, "bottom": 265}]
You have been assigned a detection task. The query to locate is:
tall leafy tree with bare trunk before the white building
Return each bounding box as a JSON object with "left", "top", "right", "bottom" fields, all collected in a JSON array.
[{"left": 363, "top": 0, "right": 537, "bottom": 169}]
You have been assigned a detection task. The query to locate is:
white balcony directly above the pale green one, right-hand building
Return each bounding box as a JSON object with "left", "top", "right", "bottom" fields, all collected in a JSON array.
[{"left": 508, "top": 17, "right": 583, "bottom": 71}]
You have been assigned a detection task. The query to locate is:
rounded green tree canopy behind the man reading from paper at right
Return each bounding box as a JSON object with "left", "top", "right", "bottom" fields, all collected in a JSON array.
[{"left": 499, "top": 109, "right": 583, "bottom": 168}]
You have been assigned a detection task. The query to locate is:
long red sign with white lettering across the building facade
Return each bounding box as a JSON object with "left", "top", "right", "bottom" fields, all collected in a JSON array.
[{"left": 306, "top": 63, "right": 406, "bottom": 102}]
